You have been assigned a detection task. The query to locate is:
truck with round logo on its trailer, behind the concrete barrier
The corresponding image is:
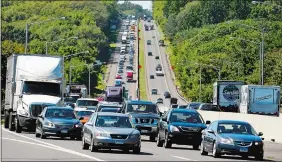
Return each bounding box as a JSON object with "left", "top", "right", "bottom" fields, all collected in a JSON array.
[{"left": 213, "top": 80, "right": 246, "bottom": 112}]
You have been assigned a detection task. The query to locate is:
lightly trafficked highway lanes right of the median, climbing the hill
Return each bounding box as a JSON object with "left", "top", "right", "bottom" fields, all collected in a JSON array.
[{"left": 141, "top": 20, "right": 186, "bottom": 107}]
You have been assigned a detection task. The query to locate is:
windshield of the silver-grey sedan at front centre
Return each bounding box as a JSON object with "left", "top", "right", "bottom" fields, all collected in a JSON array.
[{"left": 95, "top": 115, "right": 133, "bottom": 128}]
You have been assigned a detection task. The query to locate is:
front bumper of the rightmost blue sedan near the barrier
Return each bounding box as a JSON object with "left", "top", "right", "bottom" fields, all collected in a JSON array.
[{"left": 217, "top": 143, "right": 263, "bottom": 156}]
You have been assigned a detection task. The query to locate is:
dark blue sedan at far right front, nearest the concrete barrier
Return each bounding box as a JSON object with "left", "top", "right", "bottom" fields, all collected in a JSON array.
[{"left": 201, "top": 120, "right": 264, "bottom": 160}]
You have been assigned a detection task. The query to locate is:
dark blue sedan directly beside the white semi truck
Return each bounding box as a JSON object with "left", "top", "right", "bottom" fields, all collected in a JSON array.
[{"left": 35, "top": 106, "right": 83, "bottom": 140}]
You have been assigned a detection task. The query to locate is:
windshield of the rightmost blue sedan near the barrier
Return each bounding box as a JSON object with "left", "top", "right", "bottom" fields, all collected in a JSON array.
[{"left": 217, "top": 123, "right": 257, "bottom": 135}]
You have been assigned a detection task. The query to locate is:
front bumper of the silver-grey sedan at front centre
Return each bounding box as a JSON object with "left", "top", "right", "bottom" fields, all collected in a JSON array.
[{"left": 94, "top": 137, "right": 141, "bottom": 149}]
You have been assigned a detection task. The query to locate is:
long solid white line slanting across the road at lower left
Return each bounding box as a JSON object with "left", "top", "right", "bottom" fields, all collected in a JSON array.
[{"left": 2, "top": 127, "right": 104, "bottom": 161}]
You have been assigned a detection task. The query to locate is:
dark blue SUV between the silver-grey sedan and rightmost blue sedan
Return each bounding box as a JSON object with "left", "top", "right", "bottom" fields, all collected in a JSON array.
[{"left": 157, "top": 109, "right": 210, "bottom": 150}]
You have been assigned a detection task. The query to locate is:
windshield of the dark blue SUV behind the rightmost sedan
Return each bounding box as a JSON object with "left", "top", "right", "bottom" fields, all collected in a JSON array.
[{"left": 170, "top": 112, "right": 204, "bottom": 123}]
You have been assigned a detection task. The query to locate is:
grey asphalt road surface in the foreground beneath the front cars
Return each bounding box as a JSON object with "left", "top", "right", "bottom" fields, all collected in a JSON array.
[{"left": 1, "top": 128, "right": 282, "bottom": 161}]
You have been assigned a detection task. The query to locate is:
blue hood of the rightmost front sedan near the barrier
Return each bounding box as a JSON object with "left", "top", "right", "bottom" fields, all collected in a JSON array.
[{"left": 218, "top": 133, "right": 262, "bottom": 141}]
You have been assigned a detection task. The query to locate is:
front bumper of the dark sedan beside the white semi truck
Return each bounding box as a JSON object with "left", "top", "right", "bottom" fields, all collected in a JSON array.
[{"left": 43, "top": 127, "right": 82, "bottom": 137}]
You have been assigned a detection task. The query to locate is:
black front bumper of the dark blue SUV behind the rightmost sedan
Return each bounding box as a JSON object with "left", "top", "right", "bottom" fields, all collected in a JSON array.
[{"left": 168, "top": 132, "right": 202, "bottom": 145}]
